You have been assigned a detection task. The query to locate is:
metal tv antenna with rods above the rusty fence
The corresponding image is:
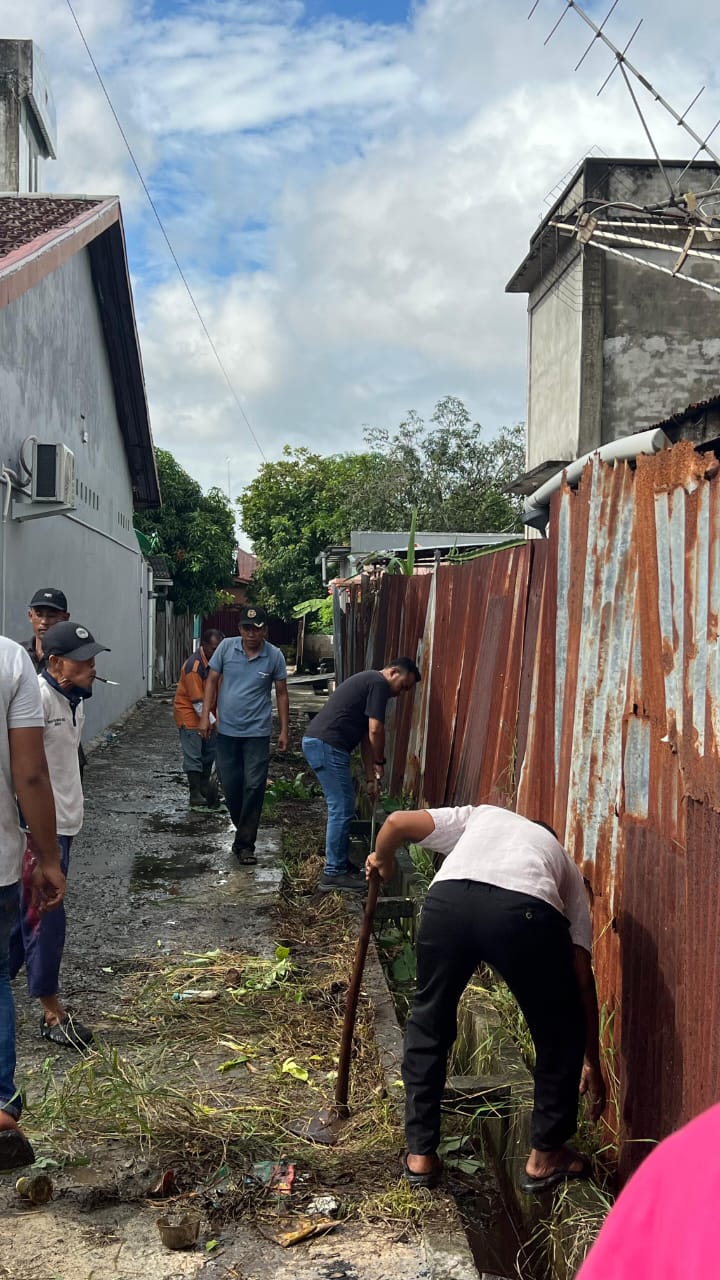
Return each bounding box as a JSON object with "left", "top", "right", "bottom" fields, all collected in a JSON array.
[{"left": 528, "top": 0, "right": 720, "bottom": 293}]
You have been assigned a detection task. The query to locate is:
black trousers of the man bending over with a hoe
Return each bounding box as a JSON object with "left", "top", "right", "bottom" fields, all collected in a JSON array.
[{"left": 402, "top": 881, "right": 585, "bottom": 1156}]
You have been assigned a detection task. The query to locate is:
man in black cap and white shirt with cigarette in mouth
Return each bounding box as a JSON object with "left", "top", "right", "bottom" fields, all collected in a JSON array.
[{"left": 10, "top": 622, "right": 110, "bottom": 1051}]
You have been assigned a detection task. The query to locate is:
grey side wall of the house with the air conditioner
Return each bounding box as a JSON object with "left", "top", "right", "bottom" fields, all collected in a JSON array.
[{"left": 0, "top": 250, "right": 147, "bottom": 739}]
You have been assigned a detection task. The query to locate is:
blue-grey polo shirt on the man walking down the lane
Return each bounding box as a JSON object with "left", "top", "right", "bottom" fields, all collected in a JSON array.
[{"left": 210, "top": 636, "right": 287, "bottom": 737}]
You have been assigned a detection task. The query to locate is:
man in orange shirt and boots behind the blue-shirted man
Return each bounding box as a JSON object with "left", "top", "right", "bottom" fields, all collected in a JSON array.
[{"left": 174, "top": 631, "right": 223, "bottom": 810}]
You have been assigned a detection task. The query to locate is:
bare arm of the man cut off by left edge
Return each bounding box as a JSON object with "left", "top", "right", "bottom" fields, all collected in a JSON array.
[{"left": 8, "top": 728, "right": 65, "bottom": 911}]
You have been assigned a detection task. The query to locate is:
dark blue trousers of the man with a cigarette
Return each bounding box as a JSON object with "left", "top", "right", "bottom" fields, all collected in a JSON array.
[{"left": 10, "top": 835, "right": 73, "bottom": 1000}]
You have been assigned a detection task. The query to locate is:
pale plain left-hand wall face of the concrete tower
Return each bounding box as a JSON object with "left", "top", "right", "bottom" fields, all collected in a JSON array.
[{"left": 527, "top": 255, "right": 583, "bottom": 468}]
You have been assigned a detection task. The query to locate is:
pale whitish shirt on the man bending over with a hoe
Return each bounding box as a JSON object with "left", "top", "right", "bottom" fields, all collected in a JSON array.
[{"left": 420, "top": 804, "right": 592, "bottom": 951}]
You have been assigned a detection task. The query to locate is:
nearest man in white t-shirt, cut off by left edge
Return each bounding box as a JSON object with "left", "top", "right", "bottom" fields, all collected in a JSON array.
[{"left": 0, "top": 636, "right": 65, "bottom": 1169}]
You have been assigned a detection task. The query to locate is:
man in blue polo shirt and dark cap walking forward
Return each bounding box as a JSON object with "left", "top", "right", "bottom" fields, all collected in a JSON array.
[{"left": 197, "top": 605, "right": 290, "bottom": 865}]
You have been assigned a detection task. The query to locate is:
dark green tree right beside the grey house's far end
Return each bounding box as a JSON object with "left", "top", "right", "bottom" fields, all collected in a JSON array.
[{"left": 135, "top": 449, "right": 236, "bottom": 613}]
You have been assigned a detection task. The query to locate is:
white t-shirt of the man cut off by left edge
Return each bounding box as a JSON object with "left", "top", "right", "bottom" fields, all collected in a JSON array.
[{"left": 0, "top": 636, "right": 44, "bottom": 884}]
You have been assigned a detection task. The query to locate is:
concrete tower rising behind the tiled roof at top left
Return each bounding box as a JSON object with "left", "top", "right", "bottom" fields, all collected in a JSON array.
[{"left": 0, "top": 40, "right": 55, "bottom": 191}]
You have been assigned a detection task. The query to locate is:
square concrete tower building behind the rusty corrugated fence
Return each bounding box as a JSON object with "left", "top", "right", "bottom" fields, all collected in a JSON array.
[{"left": 507, "top": 156, "right": 720, "bottom": 493}]
